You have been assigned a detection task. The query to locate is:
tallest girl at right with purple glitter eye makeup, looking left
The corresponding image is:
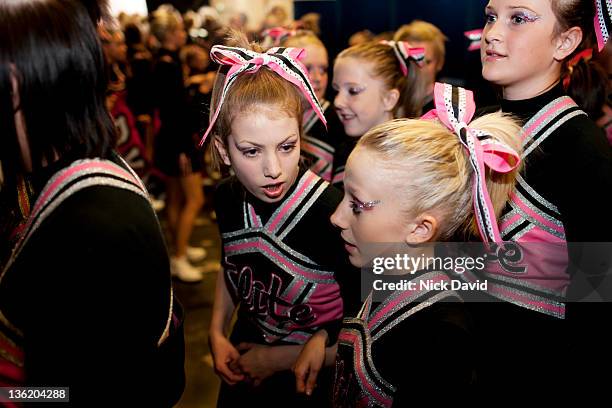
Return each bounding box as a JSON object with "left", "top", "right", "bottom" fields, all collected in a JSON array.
[{"left": 474, "top": 0, "right": 612, "bottom": 382}]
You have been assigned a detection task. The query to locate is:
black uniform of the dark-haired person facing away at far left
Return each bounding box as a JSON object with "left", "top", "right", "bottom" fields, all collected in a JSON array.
[{"left": 0, "top": 153, "right": 184, "bottom": 407}]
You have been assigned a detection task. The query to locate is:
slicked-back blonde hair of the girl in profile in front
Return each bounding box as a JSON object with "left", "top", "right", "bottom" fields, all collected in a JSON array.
[{"left": 357, "top": 112, "right": 521, "bottom": 241}]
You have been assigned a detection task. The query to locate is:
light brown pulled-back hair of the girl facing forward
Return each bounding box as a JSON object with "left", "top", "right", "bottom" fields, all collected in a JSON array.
[{"left": 209, "top": 31, "right": 306, "bottom": 169}]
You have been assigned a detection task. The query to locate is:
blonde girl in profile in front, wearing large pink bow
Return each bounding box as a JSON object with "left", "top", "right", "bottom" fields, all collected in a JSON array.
[{"left": 295, "top": 84, "right": 520, "bottom": 407}]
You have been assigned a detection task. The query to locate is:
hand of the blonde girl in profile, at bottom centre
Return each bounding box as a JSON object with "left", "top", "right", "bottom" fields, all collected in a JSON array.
[{"left": 293, "top": 330, "right": 327, "bottom": 395}]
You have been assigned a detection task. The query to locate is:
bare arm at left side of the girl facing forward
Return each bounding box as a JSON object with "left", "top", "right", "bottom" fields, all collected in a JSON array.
[{"left": 209, "top": 269, "right": 244, "bottom": 385}]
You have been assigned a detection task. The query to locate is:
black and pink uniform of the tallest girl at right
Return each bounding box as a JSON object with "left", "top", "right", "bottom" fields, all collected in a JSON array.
[{"left": 470, "top": 84, "right": 612, "bottom": 391}]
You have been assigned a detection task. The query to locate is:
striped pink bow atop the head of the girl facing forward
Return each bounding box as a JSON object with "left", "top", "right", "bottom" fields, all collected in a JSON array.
[{"left": 200, "top": 45, "right": 327, "bottom": 146}]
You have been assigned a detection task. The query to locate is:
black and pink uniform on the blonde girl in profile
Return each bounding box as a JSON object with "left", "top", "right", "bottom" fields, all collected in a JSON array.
[{"left": 333, "top": 270, "right": 474, "bottom": 408}]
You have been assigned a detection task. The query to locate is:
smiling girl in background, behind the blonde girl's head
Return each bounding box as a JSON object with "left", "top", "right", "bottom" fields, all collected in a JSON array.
[{"left": 332, "top": 42, "right": 425, "bottom": 187}]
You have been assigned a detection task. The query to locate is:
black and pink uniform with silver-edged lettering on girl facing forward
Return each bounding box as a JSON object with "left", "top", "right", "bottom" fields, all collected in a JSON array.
[{"left": 215, "top": 170, "right": 359, "bottom": 406}]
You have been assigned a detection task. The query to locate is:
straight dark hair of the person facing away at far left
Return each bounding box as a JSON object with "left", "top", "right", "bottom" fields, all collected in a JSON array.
[{"left": 0, "top": 0, "right": 115, "bottom": 178}]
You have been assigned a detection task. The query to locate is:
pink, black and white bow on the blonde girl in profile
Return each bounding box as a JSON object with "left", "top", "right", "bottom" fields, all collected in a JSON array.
[{"left": 422, "top": 82, "right": 521, "bottom": 243}]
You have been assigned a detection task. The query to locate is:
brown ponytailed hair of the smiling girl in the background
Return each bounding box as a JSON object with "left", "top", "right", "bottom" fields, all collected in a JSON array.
[{"left": 336, "top": 42, "right": 425, "bottom": 118}]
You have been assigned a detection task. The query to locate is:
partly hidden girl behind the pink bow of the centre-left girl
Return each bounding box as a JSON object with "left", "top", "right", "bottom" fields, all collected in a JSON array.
[{"left": 282, "top": 30, "right": 344, "bottom": 181}]
